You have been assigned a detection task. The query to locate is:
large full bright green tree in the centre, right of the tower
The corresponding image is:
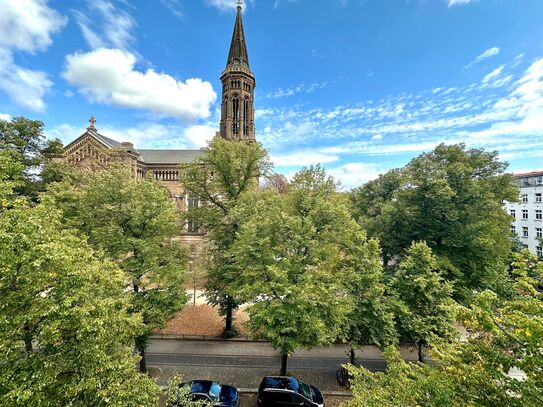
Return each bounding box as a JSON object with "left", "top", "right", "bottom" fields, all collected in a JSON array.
[{"left": 229, "top": 167, "right": 383, "bottom": 374}]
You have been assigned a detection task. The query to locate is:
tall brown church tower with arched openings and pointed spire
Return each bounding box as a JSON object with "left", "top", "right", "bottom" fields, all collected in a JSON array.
[{"left": 220, "top": 1, "right": 256, "bottom": 141}]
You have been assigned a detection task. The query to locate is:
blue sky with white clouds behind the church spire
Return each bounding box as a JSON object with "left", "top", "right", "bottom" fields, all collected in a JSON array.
[{"left": 0, "top": 0, "right": 543, "bottom": 188}]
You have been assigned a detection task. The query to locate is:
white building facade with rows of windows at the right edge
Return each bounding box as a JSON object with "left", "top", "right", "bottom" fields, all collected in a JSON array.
[{"left": 505, "top": 171, "right": 543, "bottom": 257}]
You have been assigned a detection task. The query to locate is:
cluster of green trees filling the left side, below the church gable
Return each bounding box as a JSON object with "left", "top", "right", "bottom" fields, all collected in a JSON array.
[{"left": 0, "top": 118, "right": 186, "bottom": 406}]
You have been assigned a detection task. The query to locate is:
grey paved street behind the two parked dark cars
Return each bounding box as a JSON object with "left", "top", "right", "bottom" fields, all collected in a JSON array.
[{"left": 147, "top": 339, "right": 385, "bottom": 392}]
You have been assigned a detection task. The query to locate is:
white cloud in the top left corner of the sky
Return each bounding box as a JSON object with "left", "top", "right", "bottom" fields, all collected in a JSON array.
[{"left": 0, "top": 0, "right": 67, "bottom": 112}]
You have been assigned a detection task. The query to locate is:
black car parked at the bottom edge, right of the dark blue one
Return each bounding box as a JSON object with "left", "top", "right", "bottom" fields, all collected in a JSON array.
[{"left": 257, "top": 376, "right": 324, "bottom": 407}]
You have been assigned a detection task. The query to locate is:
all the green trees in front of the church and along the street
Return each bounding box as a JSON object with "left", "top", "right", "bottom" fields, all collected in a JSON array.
[{"left": 0, "top": 118, "right": 543, "bottom": 406}]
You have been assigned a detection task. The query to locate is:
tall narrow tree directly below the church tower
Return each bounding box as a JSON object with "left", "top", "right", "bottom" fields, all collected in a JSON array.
[{"left": 180, "top": 137, "right": 270, "bottom": 337}]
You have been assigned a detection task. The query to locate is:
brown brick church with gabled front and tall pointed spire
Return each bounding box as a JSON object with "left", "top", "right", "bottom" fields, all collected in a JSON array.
[{"left": 63, "top": 3, "right": 256, "bottom": 244}]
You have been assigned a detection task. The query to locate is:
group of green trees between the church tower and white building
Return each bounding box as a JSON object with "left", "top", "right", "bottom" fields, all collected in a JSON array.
[{"left": 182, "top": 140, "right": 517, "bottom": 374}]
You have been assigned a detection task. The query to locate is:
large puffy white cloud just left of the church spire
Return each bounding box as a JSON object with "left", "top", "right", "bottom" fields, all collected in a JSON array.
[{"left": 62, "top": 48, "right": 217, "bottom": 121}]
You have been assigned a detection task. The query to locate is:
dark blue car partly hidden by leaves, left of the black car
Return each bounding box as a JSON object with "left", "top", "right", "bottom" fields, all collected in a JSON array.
[{"left": 171, "top": 380, "right": 239, "bottom": 407}]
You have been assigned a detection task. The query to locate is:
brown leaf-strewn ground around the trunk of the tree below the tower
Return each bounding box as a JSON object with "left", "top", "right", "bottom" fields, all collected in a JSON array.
[{"left": 157, "top": 304, "right": 249, "bottom": 336}]
